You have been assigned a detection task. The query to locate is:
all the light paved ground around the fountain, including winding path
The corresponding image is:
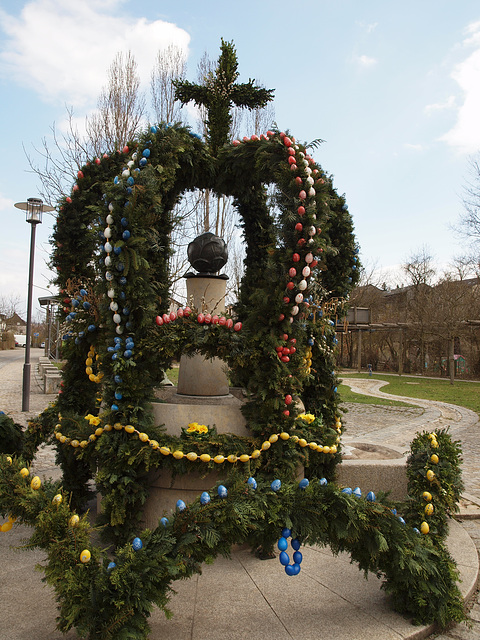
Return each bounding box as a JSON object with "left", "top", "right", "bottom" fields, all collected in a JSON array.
[{"left": 0, "top": 360, "right": 480, "bottom": 640}]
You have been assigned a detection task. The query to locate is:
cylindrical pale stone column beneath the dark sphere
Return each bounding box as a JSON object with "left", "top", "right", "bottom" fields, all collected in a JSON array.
[{"left": 177, "top": 274, "right": 229, "bottom": 397}]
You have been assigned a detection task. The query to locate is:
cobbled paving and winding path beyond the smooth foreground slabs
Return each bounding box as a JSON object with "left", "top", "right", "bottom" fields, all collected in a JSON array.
[{"left": 0, "top": 358, "right": 480, "bottom": 640}]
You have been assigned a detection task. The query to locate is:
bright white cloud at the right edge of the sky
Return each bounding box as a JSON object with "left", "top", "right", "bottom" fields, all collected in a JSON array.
[{"left": 440, "top": 22, "right": 480, "bottom": 154}]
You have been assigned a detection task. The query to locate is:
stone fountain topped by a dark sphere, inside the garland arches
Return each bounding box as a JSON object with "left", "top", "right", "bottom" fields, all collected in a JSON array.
[{"left": 144, "top": 233, "right": 249, "bottom": 526}]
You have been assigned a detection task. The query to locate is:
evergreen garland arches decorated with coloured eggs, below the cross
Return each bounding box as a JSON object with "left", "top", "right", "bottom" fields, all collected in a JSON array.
[{"left": 0, "top": 125, "right": 463, "bottom": 639}]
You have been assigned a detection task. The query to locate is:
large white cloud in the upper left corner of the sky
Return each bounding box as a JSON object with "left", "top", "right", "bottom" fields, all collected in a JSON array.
[{"left": 0, "top": 0, "right": 190, "bottom": 106}]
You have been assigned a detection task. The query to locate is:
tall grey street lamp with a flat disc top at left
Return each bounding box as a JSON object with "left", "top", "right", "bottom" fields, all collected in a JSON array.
[{"left": 14, "top": 198, "right": 54, "bottom": 411}]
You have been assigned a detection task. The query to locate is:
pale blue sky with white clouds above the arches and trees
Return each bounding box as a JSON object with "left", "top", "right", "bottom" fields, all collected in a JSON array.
[{"left": 0, "top": 0, "right": 480, "bottom": 315}]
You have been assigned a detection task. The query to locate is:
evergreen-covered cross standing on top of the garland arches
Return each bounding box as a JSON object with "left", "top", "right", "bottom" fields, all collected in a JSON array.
[{"left": 174, "top": 38, "right": 273, "bottom": 156}]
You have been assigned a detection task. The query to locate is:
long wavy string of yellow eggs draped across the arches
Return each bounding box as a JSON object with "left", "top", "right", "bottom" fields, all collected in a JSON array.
[{"left": 54, "top": 414, "right": 341, "bottom": 464}]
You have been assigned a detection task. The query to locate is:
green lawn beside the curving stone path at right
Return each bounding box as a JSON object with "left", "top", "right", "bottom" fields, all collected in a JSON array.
[{"left": 339, "top": 373, "right": 480, "bottom": 415}]
